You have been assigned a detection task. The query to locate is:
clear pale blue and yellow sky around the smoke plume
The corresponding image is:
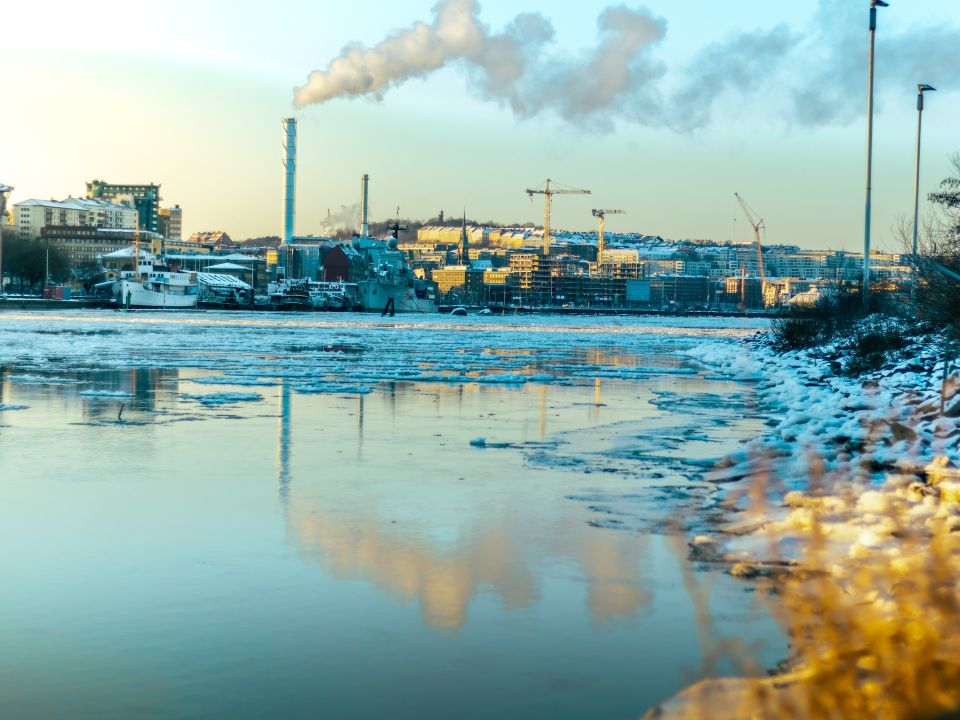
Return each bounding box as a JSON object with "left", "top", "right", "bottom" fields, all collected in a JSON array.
[{"left": 0, "top": 0, "right": 960, "bottom": 249}]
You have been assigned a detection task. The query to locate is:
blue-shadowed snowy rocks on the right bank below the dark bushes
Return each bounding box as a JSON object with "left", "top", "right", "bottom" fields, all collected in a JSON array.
[{"left": 686, "top": 324, "right": 960, "bottom": 489}]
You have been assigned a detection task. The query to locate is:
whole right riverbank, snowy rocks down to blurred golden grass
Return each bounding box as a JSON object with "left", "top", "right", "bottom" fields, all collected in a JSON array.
[{"left": 647, "top": 317, "right": 960, "bottom": 720}]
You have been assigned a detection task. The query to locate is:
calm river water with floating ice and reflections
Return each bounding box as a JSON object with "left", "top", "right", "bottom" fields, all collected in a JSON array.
[{"left": 0, "top": 311, "right": 786, "bottom": 719}]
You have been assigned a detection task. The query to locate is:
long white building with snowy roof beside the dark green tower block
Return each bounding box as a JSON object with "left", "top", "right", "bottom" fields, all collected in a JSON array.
[{"left": 13, "top": 198, "right": 137, "bottom": 238}]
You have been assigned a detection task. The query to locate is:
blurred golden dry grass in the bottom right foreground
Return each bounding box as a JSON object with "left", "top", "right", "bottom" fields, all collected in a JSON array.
[{"left": 647, "top": 458, "right": 960, "bottom": 720}]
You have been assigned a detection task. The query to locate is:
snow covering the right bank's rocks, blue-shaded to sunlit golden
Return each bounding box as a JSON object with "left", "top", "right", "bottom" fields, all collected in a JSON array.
[{"left": 685, "top": 318, "right": 960, "bottom": 566}]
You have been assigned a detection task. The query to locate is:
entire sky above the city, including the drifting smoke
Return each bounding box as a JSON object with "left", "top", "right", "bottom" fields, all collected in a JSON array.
[{"left": 0, "top": 0, "right": 960, "bottom": 251}]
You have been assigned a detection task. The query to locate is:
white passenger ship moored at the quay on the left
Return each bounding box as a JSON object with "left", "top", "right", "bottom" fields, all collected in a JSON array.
[{"left": 97, "top": 246, "right": 200, "bottom": 308}]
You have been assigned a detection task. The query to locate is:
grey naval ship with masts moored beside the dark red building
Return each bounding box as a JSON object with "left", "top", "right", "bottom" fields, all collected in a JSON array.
[{"left": 354, "top": 237, "right": 437, "bottom": 313}]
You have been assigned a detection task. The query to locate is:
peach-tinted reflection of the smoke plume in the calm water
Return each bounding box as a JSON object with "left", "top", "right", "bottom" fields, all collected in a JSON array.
[{"left": 288, "top": 504, "right": 652, "bottom": 631}]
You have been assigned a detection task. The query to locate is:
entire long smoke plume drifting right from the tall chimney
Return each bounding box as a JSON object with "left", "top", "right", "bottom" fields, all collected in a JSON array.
[{"left": 296, "top": 0, "right": 960, "bottom": 130}]
